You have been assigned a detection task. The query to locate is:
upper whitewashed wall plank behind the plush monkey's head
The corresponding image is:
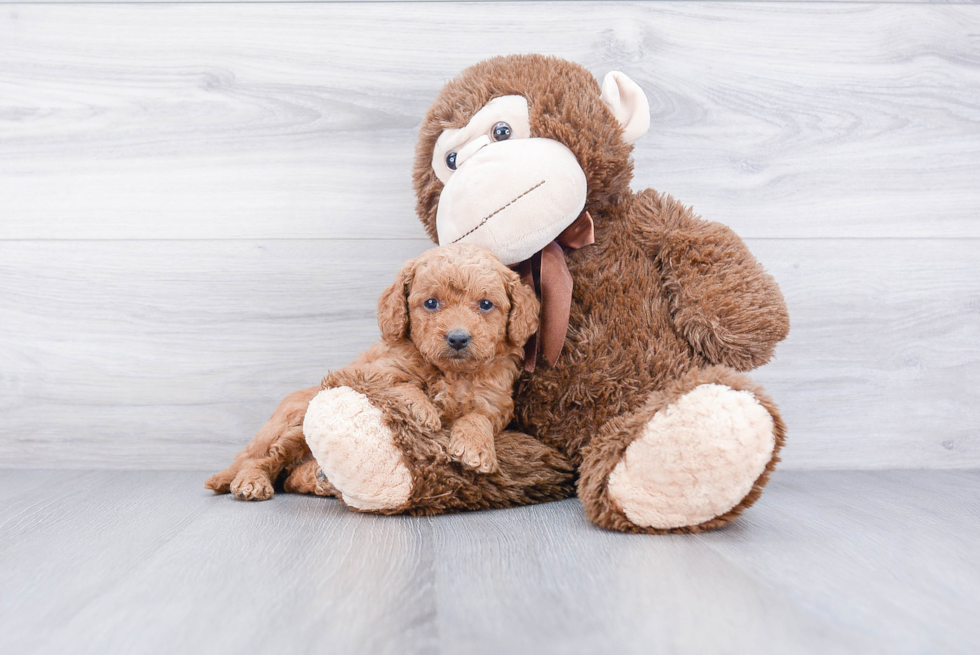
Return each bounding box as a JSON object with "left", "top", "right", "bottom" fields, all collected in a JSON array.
[{"left": 0, "top": 2, "right": 980, "bottom": 239}]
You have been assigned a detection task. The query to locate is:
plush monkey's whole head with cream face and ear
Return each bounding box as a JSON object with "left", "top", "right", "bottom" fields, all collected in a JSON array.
[{"left": 414, "top": 55, "right": 650, "bottom": 264}]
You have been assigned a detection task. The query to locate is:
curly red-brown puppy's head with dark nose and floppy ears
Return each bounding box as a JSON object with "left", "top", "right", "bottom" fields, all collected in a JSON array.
[{"left": 378, "top": 244, "right": 538, "bottom": 371}]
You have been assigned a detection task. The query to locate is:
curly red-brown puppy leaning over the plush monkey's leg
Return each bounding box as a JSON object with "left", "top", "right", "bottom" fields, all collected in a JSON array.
[{"left": 205, "top": 244, "right": 539, "bottom": 500}]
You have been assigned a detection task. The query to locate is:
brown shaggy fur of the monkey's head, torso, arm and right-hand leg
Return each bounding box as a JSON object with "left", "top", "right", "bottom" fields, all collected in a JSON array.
[{"left": 414, "top": 55, "right": 789, "bottom": 532}]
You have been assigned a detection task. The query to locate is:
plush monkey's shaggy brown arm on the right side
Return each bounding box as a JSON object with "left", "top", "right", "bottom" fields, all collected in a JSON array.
[{"left": 633, "top": 190, "right": 789, "bottom": 371}]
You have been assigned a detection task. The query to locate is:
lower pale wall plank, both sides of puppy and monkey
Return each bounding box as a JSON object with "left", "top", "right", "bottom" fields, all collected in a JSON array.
[{"left": 0, "top": 239, "right": 980, "bottom": 469}]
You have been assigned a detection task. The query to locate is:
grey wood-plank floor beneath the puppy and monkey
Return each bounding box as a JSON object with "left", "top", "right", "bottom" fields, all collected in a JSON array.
[{"left": 0, "top": 471, "right": 980, "bottom": 654}]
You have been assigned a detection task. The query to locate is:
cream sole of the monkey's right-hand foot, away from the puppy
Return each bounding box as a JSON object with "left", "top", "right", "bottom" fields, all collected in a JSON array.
[{"left": 607, "top": 384, "right": 776, "bottom": 531}]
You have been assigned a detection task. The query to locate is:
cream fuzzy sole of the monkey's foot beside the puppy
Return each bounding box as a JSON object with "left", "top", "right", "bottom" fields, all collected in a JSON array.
[{"left": 303, "top": 387, "right": 412, "bottom": 512}]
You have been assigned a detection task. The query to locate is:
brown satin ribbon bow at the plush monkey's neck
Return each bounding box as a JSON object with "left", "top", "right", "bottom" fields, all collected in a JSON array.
[{"left": 511, "top": 211, "right": 595, "bottom": 371}]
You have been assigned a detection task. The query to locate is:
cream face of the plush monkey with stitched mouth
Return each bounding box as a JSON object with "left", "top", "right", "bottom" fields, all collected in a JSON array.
[{"left": 432, "top": 95, "right": 587, "bottom": 264}]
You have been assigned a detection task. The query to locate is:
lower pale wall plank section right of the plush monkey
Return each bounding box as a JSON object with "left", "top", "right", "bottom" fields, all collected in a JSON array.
[{"left": 749, "top": 239, "right": 980, "bottom": 468}]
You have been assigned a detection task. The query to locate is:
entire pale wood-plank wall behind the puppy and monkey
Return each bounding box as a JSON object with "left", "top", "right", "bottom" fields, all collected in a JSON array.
[{"left": 0, "top": 2, "right": 980, "bottom": 468}]
